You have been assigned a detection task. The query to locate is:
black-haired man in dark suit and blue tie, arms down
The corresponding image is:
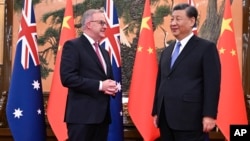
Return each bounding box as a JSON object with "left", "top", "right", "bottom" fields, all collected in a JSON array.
[{"left": 152, "top": 4, "right": 221, "bottom": 141}]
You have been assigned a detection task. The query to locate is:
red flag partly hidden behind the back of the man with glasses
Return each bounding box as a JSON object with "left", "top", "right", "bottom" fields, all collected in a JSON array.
[{"left": 47, "top": 0, "right": 76, "bottom": 141}]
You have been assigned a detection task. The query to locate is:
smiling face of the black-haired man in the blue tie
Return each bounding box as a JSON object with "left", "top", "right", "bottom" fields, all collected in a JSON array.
[{"left": 170, "top": 9, "right": 195, "bottom": 40}]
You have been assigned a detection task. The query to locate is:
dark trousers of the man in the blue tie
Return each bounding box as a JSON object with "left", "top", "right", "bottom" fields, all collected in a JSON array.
[{"left": 158, "top": 106, "right": 208, "bottom": 141}]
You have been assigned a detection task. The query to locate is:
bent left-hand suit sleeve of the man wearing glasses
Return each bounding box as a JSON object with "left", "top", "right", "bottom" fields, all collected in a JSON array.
[{"left": 60, "top": 41, "right": 100, "bottom": 93}]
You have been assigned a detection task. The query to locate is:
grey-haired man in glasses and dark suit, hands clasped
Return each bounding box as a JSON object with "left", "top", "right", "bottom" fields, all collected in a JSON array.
[{"left": 60, "top": 9, "right": 118, "bottom": 141}]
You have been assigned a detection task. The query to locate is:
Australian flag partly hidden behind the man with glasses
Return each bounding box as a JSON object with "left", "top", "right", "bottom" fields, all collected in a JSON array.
[{"left": 101, "top": 0, "right": 123, "bottom": 141}]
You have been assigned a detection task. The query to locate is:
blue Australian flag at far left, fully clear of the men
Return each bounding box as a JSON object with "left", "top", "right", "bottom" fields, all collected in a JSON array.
[{"left": 6, "top": 0, "right": 46, "bottom": 141}]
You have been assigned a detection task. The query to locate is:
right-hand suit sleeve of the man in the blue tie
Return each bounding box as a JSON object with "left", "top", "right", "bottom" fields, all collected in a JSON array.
[{"left": 203, "top": 43, "right": 221, "bottom": 119}]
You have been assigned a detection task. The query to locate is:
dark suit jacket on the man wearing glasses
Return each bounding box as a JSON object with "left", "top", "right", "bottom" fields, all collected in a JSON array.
[{"left": 59, "top": 35, "right": 113, "bottom": 124}]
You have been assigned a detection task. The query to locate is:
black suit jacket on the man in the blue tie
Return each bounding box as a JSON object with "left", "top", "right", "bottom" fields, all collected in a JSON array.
[{"left": 152, "top": 35, "right": 221, "bottom": 130}]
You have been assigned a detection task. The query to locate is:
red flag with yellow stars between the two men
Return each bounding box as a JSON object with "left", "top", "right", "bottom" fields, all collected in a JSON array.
[{"left": 128, "top": 0, "right": 159, "bottom": 141}]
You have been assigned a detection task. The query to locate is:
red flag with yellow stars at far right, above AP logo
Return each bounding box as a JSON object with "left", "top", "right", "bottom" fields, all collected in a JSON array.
[{"left": 217, "top": 0, "right": 248, "bottom": 140}]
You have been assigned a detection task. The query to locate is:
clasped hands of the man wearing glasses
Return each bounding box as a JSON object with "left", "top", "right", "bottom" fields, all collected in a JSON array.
[{"left": 102, "top": 79, "right": 118, "bottom": 96}]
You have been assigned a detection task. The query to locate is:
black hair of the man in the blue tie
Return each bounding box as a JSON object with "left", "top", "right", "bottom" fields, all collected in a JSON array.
[{"left": 173, "top": 3, "right": 198, "bottom": 21}]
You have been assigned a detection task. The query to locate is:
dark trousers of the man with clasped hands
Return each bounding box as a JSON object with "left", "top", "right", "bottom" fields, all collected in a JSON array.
[{"left": 67, "top": 122, "right": 109, "bottom": 141}]
